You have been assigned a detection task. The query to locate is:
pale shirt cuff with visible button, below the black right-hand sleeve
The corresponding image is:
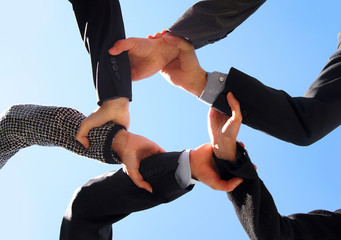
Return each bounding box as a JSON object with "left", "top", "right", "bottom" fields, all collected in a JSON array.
[{"left": 199, "top": 72, "right": 227, "bottom": 106}]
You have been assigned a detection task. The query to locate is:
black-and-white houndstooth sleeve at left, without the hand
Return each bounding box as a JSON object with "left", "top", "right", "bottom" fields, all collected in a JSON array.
[{"left": 0, "top": 104, "right": 123, "bottom": 168}]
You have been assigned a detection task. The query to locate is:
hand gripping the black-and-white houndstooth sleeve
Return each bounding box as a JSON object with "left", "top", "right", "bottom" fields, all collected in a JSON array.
[{"left": 76, "top": 98, "right": 130, "bottom": 149}]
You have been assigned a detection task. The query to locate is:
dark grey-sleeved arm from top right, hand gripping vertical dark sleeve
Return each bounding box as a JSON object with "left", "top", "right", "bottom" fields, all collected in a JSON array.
[{"left": 109, "top": 0, "right": 265, "bottom": 80}]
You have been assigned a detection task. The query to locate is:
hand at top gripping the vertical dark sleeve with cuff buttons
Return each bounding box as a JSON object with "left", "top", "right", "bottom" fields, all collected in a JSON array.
[{"left": 109, "top": 32, "right": 179, "bottom": 81}]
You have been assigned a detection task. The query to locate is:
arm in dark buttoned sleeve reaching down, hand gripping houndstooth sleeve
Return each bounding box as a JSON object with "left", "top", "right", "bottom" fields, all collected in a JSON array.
[{"left": 70, "top": 0, "right": 132, "bottom": 148}]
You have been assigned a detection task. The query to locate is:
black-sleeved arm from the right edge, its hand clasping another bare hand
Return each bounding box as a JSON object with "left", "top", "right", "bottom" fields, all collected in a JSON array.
[{"left": 162, "top": 37, "right": 341, "bottom": 145}]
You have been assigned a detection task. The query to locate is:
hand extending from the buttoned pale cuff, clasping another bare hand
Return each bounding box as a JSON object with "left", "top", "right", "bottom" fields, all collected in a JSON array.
[{"left": 156, "top": 33, "right": 207, "bottom": 97}]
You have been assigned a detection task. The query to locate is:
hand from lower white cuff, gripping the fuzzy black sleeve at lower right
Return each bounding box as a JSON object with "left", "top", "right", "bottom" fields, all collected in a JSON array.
[{"left": 190, "top": 143, "right": 243, "bottom": 192}]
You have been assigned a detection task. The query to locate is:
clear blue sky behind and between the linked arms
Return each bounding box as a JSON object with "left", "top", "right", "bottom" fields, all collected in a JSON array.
[{"left": 0, "top": 0, "right": 341, "bottom": 240}]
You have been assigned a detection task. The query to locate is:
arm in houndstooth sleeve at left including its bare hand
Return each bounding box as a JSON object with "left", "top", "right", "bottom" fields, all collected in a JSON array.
[{"left": 0, "top": 104, "right": 164, "bottom": 192}]
